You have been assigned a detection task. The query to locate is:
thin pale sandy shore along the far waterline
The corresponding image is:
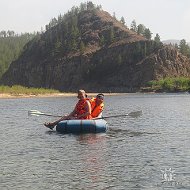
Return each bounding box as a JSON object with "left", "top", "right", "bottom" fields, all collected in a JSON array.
[{"left": 0, "top": 93, "right": 126, "bottom": 99}]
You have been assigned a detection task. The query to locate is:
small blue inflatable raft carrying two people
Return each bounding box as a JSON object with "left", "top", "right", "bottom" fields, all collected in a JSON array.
[{"left": 56, "top": 119, "right": 108, "bottom": 134}]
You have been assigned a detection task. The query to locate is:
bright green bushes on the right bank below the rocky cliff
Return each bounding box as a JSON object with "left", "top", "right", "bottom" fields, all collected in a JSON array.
[{"left": 147, "top": 77, "right": 190, "bottom": 92}]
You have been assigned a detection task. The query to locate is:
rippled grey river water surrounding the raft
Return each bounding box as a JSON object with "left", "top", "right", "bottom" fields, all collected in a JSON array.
[{"left": 0, "top": 94, "right": 190, "bottom": 190}]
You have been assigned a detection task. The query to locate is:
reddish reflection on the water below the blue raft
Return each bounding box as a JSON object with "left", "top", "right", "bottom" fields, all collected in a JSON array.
[{"left": 72, "top": 134, "right": 107, "bottom": 189}]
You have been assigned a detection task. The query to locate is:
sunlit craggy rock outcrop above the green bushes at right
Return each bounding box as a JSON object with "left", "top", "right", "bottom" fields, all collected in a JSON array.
[{"left": 131, "top": 46, "right": 190, "bottom": 86}]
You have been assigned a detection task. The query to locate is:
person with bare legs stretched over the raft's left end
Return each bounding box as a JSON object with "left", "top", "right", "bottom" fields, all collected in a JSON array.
[{"left": 44, "top": 90, "right": 91, "bottom": 129}]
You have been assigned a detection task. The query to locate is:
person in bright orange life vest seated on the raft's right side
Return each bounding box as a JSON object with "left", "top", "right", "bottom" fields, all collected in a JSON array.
[{"left": 90, "top": 94, "right": 104, "bottom": 118}]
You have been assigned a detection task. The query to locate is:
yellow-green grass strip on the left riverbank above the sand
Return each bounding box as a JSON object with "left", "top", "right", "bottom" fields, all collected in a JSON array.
[{"left": 0, "top": 85, "right": 60, "bottom": 95}]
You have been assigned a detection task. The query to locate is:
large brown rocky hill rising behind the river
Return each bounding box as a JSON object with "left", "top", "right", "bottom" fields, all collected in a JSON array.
[{"left": 0, "top": 9, "right": 190, "bottom": 92}]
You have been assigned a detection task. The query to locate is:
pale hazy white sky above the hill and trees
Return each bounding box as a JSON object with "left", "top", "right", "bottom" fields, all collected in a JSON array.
[{"left": 0, "top": 0, "right": 190, "bottom": 42}]
